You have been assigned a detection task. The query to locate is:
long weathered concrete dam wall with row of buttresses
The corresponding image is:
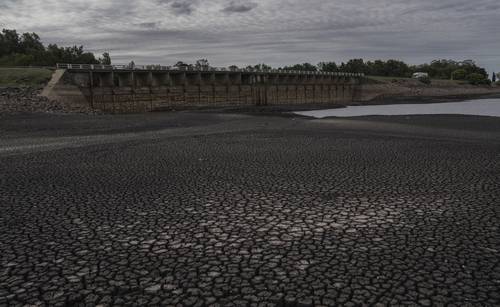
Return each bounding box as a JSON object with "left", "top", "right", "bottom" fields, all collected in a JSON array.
[{"left": 44, "top": 64, "right": 362, "bottom": 113}]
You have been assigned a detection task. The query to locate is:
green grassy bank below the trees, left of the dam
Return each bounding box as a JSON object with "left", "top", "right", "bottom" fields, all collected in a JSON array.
[{"left": 0, "top": 67, "right": 52, "bottom": 86}]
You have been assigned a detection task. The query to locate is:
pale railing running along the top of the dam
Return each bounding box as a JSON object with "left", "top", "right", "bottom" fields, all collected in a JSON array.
[{"left": 56, "top": 64, "right": 365, "bottom": 77}]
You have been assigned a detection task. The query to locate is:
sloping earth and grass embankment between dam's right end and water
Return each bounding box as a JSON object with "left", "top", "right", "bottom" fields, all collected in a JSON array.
[{"left": 359, "top": 78, "right": 500, "bottom": 103}]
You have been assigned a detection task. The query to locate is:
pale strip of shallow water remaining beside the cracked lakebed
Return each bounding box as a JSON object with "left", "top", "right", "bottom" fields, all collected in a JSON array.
[{"left": 295, "top": 98, "right": 500, "bottom": 118}]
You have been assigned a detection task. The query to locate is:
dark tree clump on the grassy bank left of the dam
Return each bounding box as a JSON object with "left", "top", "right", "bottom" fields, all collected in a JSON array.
[{"left": 0, "top": 29, "right": 111, "bottom": 66}]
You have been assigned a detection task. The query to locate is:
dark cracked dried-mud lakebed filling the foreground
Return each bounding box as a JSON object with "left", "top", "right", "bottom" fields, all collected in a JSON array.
[{"left": 0, "top": 112, "right": 500, "bottom": 306}]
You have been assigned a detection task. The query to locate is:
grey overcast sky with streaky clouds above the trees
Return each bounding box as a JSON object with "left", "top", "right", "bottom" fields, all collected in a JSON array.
[{"left": 0, "top": 0, "right": 500, "bottom": 71}]
